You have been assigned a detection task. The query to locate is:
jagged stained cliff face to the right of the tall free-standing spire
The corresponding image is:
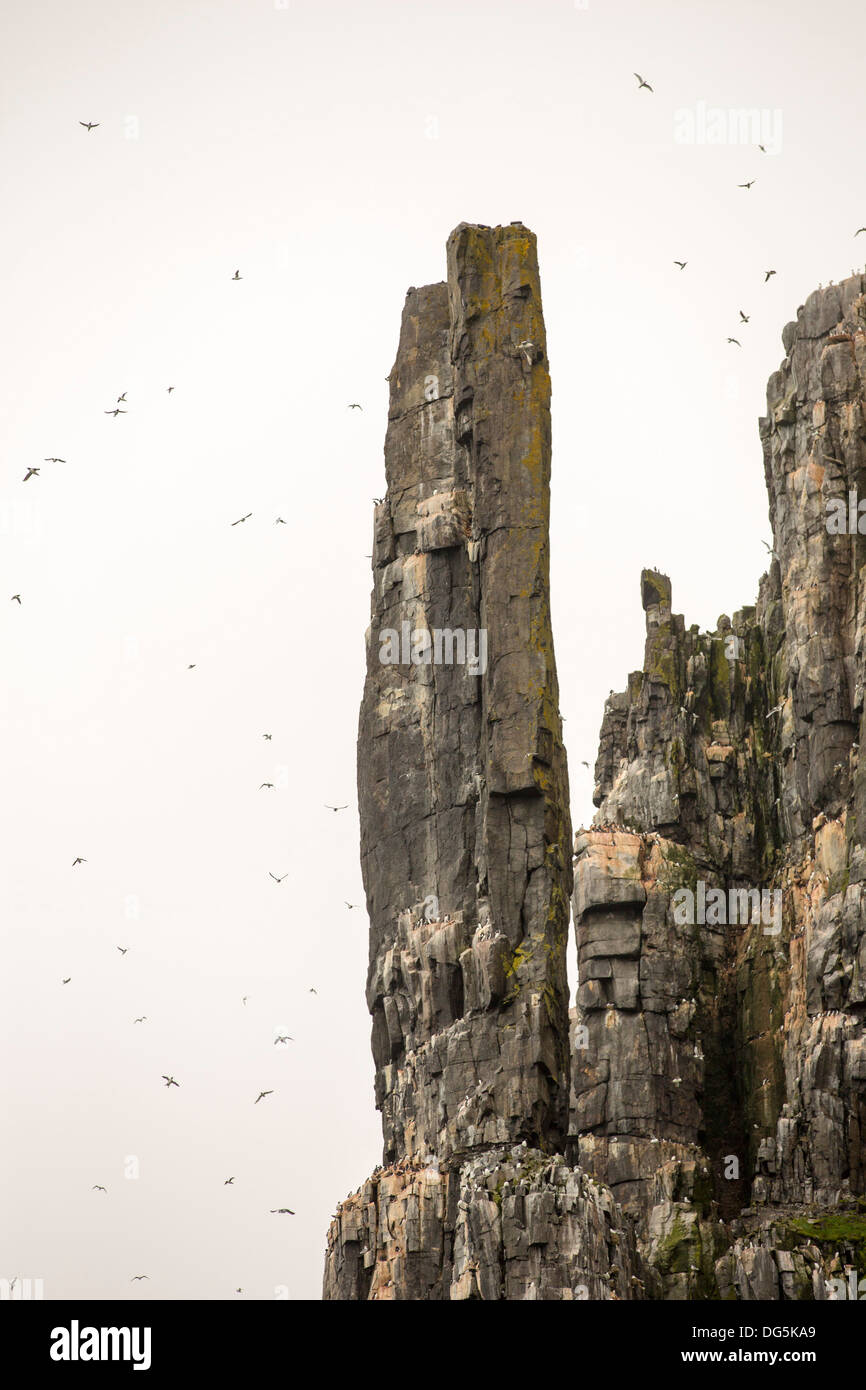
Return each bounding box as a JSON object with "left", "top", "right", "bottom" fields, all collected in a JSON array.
[{"left": 567, "top": 277, "right": 866, "bottom": 1298}]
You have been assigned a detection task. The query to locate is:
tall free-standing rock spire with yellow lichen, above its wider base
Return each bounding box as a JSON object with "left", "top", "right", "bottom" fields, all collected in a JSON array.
[{"left": 359, "top": 224, "right": 571, "bottom": 1162}]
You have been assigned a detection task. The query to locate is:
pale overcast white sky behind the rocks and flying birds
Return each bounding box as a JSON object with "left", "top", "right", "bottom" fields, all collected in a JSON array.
[{"left": 0, "top": 0, "right": 866, "bottom": 1298}]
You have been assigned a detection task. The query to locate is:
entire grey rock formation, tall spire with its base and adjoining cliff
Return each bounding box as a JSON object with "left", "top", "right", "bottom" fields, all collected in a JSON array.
[{"left": 324, "top": 236, "right": 866, "bottom": 1300}]
